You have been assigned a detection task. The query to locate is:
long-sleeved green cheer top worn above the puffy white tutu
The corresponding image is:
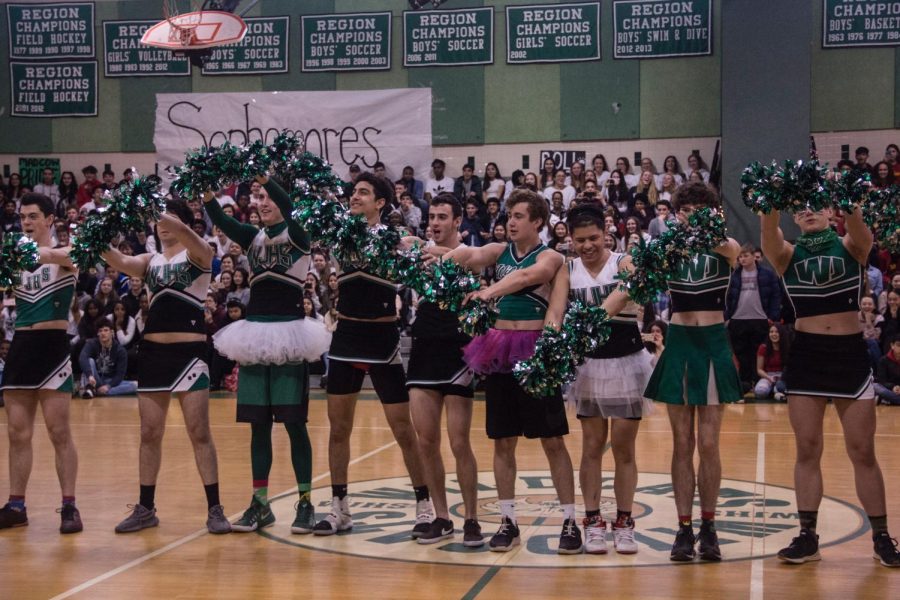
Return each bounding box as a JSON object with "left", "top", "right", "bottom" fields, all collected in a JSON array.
[{"left": 206, "top": 181, "right": 310, "bottom": 321}]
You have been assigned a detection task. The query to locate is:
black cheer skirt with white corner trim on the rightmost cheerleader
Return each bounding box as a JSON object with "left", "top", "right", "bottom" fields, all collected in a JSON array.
[{"left": 782, "top": 331, "right": 875, "bottom": 400}]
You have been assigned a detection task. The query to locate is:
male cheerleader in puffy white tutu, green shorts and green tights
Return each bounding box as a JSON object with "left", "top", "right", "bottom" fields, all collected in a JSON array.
[{"left": 204, "top": 177, "right": 330, "bottom": 533}]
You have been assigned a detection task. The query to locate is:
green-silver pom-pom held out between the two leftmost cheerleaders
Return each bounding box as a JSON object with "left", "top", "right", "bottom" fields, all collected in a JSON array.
[{"left": 69, "top": 175, "right": 166, "bottom": 270}]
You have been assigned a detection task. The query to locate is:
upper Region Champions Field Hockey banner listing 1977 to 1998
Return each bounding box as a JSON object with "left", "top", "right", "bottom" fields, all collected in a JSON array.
[{"left": 6, "top": 2, "right": 94, "bottom": 60}]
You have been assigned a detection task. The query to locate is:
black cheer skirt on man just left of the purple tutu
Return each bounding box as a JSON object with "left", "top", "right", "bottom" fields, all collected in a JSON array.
[{"left": 406, "top": 337, "right": 475, "bottom": 398}]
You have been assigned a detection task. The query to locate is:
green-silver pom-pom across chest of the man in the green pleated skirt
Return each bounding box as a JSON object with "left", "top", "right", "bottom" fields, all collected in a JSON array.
[{"left": 618, "top": 207, "right": 726, "bottom": 305}]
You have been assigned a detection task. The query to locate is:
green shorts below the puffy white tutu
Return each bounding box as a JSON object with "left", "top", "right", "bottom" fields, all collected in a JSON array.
[{"left": 237, "top": 362, "right": 309, "bottom": 423}]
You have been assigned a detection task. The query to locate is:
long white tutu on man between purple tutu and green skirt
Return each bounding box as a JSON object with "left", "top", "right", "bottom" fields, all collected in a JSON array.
[{"left": 566, "top": 350, "right": 653, "bottom": 419}]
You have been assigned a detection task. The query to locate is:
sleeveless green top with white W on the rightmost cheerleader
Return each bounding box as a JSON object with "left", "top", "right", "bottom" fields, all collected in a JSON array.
[{"left": 782, "top": 235, "right": 865, "bottom": 319}]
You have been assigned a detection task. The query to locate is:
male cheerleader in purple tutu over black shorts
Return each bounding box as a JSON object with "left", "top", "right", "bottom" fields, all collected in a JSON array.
[{"left": 445, "top": 189, "right": 582, "bottom": 554}]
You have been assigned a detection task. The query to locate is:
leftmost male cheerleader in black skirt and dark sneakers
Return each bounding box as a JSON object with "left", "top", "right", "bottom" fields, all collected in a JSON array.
[{"left": 0, "top": 193, "right": 82, "bottom": 533}]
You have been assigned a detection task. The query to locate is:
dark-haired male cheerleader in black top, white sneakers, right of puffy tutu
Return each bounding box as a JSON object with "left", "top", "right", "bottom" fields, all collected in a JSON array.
[{"left": 314, "top": 172, "right": 434, "bottom": 538}]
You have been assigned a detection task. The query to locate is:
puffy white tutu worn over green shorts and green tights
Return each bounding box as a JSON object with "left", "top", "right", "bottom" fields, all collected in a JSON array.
[{"left": 213, "top": 319, "right": 331, "bottom": 365}]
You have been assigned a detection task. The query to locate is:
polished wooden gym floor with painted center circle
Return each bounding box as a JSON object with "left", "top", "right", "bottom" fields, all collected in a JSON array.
[{"left": 0, "top": 390, "right": 900, "bottom": 600}]
